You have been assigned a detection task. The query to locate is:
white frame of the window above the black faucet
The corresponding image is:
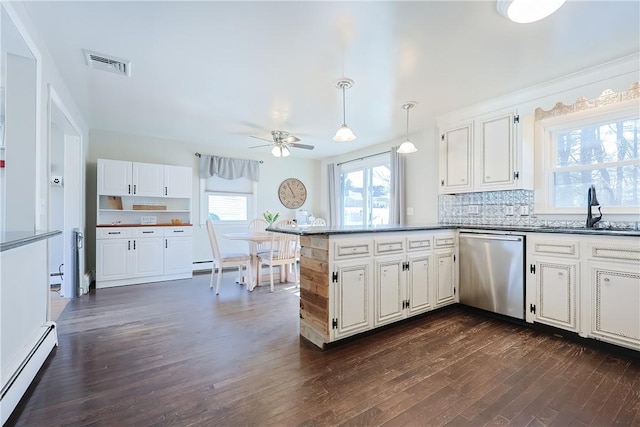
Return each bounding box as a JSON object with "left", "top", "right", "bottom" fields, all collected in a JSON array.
[{"left": 534, "top": 99, "right": 639, "bottom": 216}]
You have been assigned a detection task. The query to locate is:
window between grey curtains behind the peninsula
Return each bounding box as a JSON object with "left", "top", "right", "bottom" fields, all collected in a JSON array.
[{"left": 340, "top": 154, "right": 391, "bottom": 225}]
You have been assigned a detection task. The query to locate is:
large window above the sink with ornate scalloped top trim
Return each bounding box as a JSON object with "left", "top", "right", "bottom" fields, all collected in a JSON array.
[{"left": 535, "top": 88, "right": 640, "bottom": 215}]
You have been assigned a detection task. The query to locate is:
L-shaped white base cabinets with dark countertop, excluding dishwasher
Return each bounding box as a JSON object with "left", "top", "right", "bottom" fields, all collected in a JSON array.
[{"left": 268, "top": 224, "right": 640, "bottom": 350}]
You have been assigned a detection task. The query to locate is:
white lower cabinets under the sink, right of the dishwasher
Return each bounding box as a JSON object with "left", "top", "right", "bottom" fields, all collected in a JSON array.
[{"left": 526, "top": 233, "right": 640, "bottom": 350}]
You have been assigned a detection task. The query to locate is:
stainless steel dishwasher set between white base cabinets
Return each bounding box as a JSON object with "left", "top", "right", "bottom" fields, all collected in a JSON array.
[{"left": 459, "top": 232, "right": 525, "bottom": 319}]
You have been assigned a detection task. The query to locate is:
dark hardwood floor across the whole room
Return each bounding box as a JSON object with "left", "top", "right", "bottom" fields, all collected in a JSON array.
[{"left": 7, "top": 274, "right": 640, "bottom": 426}]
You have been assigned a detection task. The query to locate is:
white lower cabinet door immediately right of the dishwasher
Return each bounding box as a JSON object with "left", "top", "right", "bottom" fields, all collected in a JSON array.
[{"left": 535, "top": 257, "right": 579, "bottom": 331}]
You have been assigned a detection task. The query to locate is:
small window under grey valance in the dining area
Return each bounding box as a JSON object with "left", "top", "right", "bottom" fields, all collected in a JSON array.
[{"left": 201, "top": 176, "right": 256, "bottom": 225}]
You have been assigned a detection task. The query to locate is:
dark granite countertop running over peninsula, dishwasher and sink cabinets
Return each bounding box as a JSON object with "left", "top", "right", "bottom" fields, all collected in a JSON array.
[{"left": 267, "top": 224, "right": 640, "bottom": 237}]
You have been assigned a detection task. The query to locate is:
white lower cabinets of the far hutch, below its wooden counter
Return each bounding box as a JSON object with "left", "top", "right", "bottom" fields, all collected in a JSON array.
[{"left": 96, "top": 227, "right": 192, "bottom": 288}]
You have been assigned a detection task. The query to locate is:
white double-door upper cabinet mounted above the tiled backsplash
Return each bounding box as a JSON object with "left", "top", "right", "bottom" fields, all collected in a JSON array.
[{"left": 440, "top": 111, "right": 533, "bottom": 194}]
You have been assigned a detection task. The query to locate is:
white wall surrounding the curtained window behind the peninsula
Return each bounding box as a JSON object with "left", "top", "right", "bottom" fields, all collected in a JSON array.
[{"left": 313, "top": 127, "right": 438, "bottom": 225}]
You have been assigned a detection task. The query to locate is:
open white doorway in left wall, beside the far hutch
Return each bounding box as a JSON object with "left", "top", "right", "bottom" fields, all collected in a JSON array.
[{"left": 49, "top": 87, "right": 84, "bottom": 321}]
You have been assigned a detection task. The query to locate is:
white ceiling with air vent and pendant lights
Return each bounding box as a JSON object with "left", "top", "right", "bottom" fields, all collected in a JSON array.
[{"left": 25, "top": 0, "right": 640, "bottom": 158}]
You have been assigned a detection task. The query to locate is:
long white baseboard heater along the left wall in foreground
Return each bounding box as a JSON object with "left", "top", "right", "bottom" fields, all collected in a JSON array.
[{"left": 0, "top": 322, "right": 58, "bottom": 425}]
